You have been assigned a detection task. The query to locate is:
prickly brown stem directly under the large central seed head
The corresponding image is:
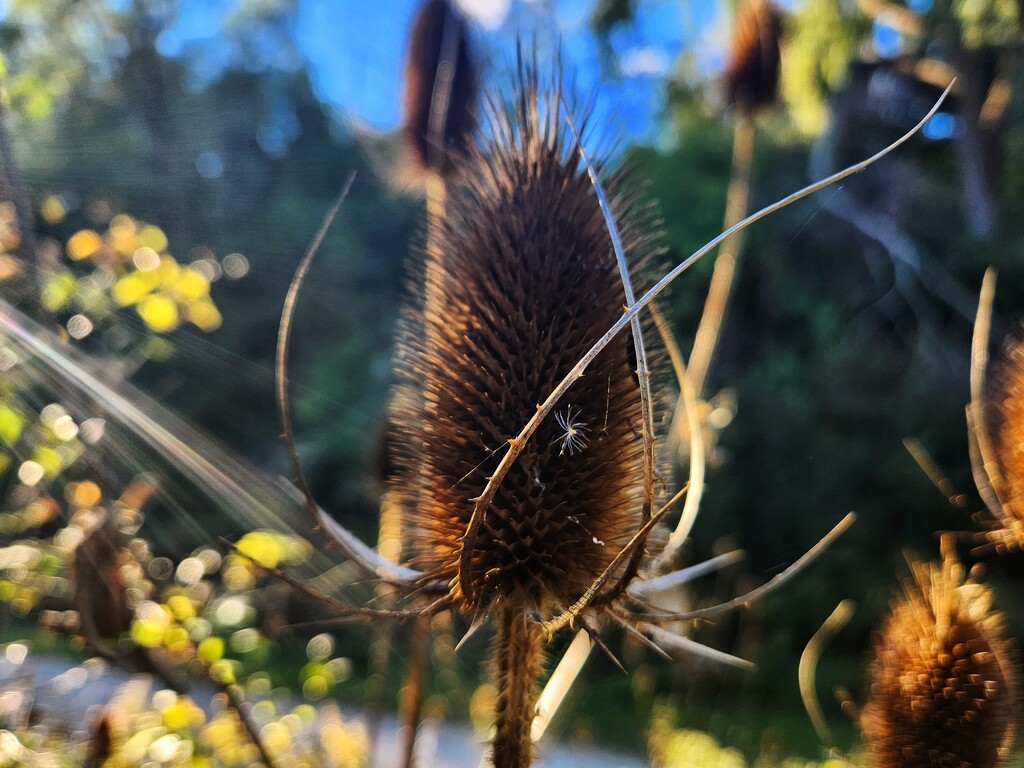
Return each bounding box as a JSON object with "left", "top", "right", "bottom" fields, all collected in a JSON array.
[{"left": 492, "top": 600, "right": 544, "bottom": 768}]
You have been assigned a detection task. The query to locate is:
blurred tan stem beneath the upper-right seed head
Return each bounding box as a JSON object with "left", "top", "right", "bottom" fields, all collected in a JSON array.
[{"left": 673, "top": 112, "right": 757, "bottom": 403}]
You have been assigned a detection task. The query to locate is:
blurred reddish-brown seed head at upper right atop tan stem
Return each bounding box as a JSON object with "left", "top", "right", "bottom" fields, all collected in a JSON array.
[{"left": 725, "top": 0, "right": 782, "bottom": 115}]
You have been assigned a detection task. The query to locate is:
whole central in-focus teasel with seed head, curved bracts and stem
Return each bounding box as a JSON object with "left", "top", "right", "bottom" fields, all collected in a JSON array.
[{"left": 278, "top": 51, "right": 941, "bottom": 767}]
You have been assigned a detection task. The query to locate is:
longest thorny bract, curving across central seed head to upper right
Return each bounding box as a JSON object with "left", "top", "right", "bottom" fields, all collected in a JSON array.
[{"left": 459, "top": 81, "right": 955, "bottom": 614}]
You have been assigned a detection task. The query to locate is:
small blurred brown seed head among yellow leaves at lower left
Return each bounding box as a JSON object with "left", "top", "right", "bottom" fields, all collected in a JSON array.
[{"left": 71, "top": 520, "right": 132, "bottom": 643}]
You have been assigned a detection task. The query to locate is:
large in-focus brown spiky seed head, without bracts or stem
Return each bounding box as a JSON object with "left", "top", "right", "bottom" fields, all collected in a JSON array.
[{"left": 393, "top": 63, "right": 652, "bottom": 611}]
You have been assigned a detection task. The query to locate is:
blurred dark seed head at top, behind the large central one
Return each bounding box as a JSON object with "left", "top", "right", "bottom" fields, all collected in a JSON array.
[{"left": 402, "top": 0, "right": 476, "bottom": 180}]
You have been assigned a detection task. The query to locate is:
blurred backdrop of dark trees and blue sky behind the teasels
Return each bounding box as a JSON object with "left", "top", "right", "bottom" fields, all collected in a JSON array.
[{"left": 0, "top": 0, "right": 1024, "bottom": 764}]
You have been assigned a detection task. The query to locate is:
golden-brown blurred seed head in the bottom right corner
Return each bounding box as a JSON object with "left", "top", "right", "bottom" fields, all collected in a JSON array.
[{"left": 861, "top": 553, "right": 1018, "bottom": 768}]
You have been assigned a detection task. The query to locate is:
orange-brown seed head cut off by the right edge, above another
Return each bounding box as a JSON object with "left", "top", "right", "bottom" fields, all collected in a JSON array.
[{"left": 982, "top": 334, "right": 1024, "bottom": 549}]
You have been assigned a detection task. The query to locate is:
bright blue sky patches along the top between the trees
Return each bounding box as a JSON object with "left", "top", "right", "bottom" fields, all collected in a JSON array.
[{"left": 160, "top": 0, "right": 724, "bottom": 138}]
